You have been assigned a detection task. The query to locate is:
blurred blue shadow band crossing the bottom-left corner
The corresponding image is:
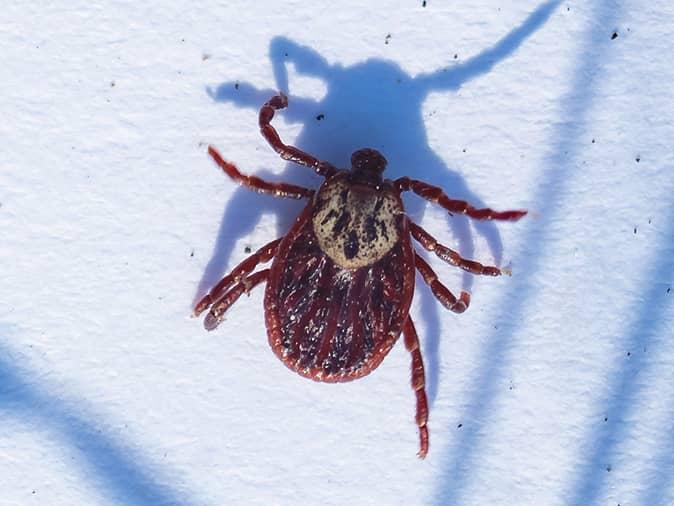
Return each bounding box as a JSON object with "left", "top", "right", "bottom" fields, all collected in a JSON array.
[{"left": 0, "top": 328, "right": 204, "bottom": 506}]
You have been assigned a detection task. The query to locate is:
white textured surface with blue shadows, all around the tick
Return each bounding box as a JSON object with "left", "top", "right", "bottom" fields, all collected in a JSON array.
[{"left": 0, "top": 0, "right": 674, "bottom": 506}]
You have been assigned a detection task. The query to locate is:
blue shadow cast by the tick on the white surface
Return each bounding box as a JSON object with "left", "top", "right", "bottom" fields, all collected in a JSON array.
[{"left": 195, "top": 0, "right": 561, "bottom": 403}]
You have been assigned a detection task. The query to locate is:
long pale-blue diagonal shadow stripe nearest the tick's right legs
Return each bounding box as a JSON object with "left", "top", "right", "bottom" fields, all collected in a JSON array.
[{"left": 433, "top": 0, "right": 622, "bottom": 506}]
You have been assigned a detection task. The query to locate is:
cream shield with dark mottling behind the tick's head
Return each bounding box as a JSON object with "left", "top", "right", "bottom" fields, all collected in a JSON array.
[{"left": 312, "top": 174, "right": 403, "bottom": 269}]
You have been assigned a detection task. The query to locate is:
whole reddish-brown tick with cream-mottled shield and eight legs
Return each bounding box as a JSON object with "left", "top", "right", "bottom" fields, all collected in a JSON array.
[{"left": 194, "top": 94, "right": 527, "bottom": 458}]
